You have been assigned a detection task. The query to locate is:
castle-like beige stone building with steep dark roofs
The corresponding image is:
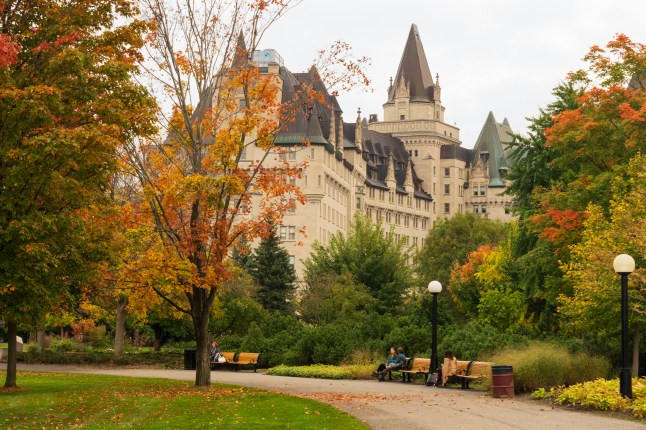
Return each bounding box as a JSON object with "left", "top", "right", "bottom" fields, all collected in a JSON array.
[{"left": 228, "top": 25, "right": 512, "bottom": 274}]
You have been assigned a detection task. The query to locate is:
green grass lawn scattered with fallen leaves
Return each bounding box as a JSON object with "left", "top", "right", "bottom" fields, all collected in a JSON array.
[{"left": 0, "top": 371, "right": 368, "bottom": 429}]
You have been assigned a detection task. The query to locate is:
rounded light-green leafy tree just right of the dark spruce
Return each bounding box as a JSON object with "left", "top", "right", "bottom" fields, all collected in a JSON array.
[{"left": 304, "top": 214, "right": 413, "bottom": 313}]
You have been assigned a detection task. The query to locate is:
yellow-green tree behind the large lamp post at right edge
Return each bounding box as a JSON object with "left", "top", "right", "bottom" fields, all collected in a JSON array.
[{"left": 559, "top": 154, "right": 646, "bottom": 376}]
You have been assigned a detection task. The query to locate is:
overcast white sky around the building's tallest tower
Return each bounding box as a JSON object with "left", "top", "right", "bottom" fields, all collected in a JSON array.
[{"left": 261, "top": 0, "right": 646, "bottom": 148}]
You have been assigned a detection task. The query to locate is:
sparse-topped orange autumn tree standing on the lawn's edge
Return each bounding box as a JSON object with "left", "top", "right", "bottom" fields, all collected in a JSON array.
[{"left": 126, "top": 0, "right": 372, "bottom": 386}]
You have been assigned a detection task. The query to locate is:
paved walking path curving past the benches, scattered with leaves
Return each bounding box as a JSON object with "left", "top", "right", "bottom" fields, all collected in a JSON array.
[{"left": 18, "top": 363, "right": 646, "bottom": 430}]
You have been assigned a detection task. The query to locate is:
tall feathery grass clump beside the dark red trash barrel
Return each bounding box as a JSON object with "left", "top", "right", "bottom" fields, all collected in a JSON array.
[{"left": 491, "top": 342, "right": 610, "bottom": 393}]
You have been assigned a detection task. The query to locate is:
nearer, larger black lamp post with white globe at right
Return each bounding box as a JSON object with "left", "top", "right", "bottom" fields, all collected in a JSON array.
[{"left": 612, "top": 254, "right": 635, "bottom": 399}]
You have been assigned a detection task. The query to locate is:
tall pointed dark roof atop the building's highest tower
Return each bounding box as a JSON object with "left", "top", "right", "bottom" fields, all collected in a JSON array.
[{"left": 388, "top": 24, "right": 434, "bottom": 103}]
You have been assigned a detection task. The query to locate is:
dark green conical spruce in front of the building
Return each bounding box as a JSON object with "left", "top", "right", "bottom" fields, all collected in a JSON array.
[{"left": 247, "top": 230, "right": 296, "bottom": 314}]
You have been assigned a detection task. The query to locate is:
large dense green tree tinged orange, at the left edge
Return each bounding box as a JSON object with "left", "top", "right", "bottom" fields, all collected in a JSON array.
[{"left": 0, "top": 0, "right": 155, "bottom": 387}]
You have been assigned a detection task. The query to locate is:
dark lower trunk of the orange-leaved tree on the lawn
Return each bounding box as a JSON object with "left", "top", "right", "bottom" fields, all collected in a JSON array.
[{"left": 191, "top": 287, "right": 211, "bottom": 387}]
